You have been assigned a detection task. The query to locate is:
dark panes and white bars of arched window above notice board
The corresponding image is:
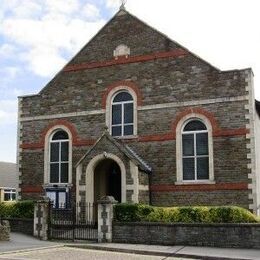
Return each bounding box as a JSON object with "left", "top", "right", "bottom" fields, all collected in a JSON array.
[{"left": 49, "top": 130, "right": 69, "bottom": 183}]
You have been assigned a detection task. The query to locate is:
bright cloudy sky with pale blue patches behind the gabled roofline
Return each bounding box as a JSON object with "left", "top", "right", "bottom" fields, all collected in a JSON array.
[{"left": 0, "top": 0, "right": 260, "bottom": 162}]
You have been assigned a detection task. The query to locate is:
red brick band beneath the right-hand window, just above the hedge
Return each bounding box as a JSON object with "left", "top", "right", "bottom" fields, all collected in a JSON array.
[{"left": 150, "top": 182, "right": 248, "bottom": 192}]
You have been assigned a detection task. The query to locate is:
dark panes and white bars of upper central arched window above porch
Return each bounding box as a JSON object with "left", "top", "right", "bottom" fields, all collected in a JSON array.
[{"left": 111, "top": 91, "right": 134, "bottom": 136}]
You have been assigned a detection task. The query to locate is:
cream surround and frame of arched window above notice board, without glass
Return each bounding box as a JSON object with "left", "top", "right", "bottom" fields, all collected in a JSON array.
[{"left": 44, "top": 125, "right": 72, "bottom": 187}]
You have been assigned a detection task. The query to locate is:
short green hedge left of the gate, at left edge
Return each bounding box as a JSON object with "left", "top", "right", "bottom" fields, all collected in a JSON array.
[{"left": 0, "top": 200, "right": 34, "bottom": 218}]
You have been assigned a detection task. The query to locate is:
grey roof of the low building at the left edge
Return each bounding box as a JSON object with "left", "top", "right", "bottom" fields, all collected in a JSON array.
[{"left": 0, "top": 162, "right": 18, "bottom": 189}]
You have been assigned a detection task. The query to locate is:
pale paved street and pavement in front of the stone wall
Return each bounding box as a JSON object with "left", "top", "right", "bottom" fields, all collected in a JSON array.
[{"left": 0, "top": 233, "right": 260, "bottom": 260}]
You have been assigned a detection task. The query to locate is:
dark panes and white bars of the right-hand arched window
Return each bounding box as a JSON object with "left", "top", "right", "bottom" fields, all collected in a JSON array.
[{"left": 182, "top": 119, "right": 209, "bottom": 181}]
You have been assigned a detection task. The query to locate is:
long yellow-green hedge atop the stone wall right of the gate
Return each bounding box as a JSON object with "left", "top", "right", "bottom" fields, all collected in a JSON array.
[{"left": 114, "top": 203, "right": 260, "bottom": 223}]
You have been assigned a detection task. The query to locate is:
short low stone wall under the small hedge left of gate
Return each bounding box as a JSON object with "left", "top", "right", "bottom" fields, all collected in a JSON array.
[{"left": 6, "top": 218, "right": 33, "bottom": 236}]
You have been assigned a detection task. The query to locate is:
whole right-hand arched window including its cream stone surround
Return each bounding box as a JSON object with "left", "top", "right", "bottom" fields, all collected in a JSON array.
[{"left": 176, "top": 113, "right": 214, "bottom": 184}]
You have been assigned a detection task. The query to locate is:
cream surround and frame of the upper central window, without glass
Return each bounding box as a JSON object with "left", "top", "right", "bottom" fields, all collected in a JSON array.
[{"left": 106, "top": 86, "right": 137, "bottom": 139}]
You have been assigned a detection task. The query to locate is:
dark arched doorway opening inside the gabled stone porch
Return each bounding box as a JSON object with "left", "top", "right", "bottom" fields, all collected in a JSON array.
[{"left": 94, "top": 159, "right": 122, "bottom": 203}]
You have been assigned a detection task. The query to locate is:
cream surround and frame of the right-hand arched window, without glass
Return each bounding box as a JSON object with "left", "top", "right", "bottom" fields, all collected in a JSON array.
[{"left": 175, "top": 113, "right": 215, "bottom": 185}]
